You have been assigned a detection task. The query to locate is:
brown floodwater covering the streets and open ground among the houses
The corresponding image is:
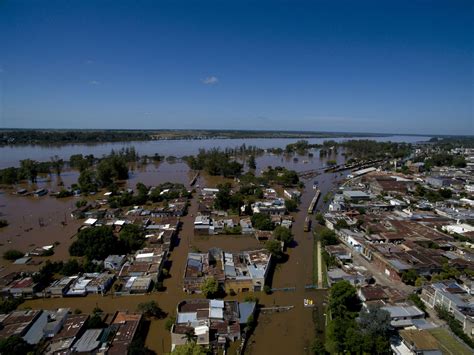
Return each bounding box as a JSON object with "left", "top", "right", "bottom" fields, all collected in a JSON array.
[{"left": 8, "top": 154, "right": 344, "bottom": 354}]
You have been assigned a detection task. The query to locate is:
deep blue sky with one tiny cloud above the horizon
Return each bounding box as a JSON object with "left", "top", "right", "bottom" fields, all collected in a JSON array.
[{"left": 0, "top": 0, "right": 474, "bottom": 134}]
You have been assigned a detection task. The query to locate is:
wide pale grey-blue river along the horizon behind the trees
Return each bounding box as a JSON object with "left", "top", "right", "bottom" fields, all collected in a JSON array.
[{"left": 0, "top": 135, "right": 430, "bottom": 168}]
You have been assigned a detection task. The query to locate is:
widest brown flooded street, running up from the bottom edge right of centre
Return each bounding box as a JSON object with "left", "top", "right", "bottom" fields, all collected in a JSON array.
[{"left": 244, "top": 169, "right": 337, "bottom": 354}]
